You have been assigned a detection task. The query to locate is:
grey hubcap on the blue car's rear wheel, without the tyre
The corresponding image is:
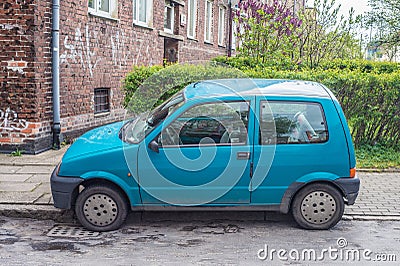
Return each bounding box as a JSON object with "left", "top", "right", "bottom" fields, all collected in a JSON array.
[{"left": 301, "top": 191, "right": 336, "bottom": 224}]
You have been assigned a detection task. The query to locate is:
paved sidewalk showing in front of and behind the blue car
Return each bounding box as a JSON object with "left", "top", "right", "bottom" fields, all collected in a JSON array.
[{"left": 0, "top": 147, "right": 400, "bottom": 220}]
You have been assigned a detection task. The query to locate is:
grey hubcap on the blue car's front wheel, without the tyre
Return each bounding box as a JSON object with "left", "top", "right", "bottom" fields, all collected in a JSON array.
[{"left": 83, "top": 194, "right": 118, "bottom": 226}]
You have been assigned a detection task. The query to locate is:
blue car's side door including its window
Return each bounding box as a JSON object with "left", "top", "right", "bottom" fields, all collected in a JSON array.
[{"left": 138, "top": 98, "right": 254, "bottom": 206}]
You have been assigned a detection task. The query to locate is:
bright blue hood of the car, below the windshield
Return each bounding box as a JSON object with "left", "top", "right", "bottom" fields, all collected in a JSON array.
[{"left": 62, "top": 122, "right": 124, "bottom": 162}]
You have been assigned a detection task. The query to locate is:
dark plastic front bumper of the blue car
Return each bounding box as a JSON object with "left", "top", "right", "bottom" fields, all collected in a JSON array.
[{"left": 50, "top": 165, "right": 83, "bottom": 209}]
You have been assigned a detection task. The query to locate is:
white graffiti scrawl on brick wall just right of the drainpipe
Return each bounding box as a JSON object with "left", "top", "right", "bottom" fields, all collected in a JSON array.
[{"left": 60, "top": 25, "right": 101, "bottom": 76}]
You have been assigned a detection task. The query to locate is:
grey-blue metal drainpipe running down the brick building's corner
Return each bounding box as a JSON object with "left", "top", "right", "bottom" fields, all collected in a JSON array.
[{"left": 51, "top": 0, "right": 61, "bottom": 149}]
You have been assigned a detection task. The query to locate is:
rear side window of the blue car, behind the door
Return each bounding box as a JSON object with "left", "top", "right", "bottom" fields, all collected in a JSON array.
[{"left": 259, "top": 101, "right": 328, "bottom": 145}]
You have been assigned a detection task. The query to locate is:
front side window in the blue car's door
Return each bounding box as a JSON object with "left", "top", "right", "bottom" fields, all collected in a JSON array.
[{"left": 158, "top": 101, "right": 250, "bottom": 147}]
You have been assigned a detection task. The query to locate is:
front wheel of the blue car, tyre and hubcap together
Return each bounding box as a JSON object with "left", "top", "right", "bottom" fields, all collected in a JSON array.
[{"left": 75, "top": 184, "right": 129, "bottom": 232}]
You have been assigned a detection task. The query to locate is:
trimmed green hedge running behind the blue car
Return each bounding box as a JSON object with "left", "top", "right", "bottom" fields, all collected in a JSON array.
[{"left": 124, "top": 58, "right": 400, "bottom": 147}]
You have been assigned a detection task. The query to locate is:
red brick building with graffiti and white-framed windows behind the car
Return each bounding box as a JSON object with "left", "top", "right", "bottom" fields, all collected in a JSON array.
[{"left": 0, "top": 0, "right": 238, "bottom": 153}]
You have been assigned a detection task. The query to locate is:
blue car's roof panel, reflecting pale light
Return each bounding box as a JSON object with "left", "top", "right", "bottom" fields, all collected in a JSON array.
[{"left": 184, "top": 79, "right": 330, "bottom": 99}]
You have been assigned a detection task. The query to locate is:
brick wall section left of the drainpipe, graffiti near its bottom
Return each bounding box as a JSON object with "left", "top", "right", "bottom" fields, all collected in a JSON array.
[{"left": 0, "top": 0, "right": 51, "bottom": 152}]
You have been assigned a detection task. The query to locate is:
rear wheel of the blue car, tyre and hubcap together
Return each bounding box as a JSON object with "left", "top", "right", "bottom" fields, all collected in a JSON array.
[{"left": 292, "top": 183, "right": 344, "bottom": 230}]
